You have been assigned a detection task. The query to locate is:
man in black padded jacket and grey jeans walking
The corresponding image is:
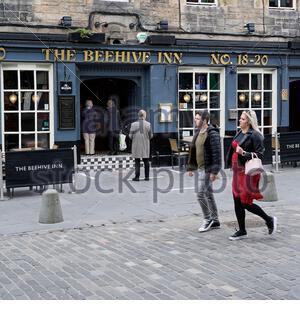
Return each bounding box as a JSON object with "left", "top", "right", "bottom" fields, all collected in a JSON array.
[{"left": 187, "top": 110, "right": 221, "bottom": 232}]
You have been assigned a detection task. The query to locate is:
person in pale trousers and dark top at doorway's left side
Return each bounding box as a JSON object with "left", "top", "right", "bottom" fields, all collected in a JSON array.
[{"left": 82, "top": 100, "right": 100, "bottom": 155}]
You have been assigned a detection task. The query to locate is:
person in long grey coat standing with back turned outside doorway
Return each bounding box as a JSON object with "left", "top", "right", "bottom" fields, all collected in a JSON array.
[{"left": 129, "top": 110, "right": 153, "bottom": 181}]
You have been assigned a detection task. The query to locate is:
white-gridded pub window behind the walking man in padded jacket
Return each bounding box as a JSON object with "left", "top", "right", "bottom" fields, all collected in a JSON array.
[{"left": 178, "top": 68, "right": 224, "bottom": 138}]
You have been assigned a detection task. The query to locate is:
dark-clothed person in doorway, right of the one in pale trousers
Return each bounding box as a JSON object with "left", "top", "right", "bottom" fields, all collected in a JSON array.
[{"left": 107, "top": 99, "right": 120, "bottom": 155}]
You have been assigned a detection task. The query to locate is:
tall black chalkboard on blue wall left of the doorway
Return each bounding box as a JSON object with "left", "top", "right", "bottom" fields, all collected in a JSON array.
[{"left": 58, "top": 96, "right": 75, "bottom": 130}]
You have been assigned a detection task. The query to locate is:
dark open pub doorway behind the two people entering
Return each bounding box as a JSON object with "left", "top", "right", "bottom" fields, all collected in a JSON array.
[{"left": 80, "top": 77, "right": 141, "bottom": 154}]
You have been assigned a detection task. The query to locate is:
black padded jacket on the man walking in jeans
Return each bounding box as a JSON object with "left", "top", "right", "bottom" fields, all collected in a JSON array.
[{"left": 187, "top": 125, "right": 221, "bottom": 174}]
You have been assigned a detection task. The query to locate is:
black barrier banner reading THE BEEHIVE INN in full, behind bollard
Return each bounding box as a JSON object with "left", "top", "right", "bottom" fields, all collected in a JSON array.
[{"left": 5, "top": 149, "right": 74, "bottom": 189}]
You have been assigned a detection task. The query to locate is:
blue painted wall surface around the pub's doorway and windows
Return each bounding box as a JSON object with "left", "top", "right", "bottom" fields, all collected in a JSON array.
[{"left": 0, "top": 42, "right": 300, "bottom": 143}]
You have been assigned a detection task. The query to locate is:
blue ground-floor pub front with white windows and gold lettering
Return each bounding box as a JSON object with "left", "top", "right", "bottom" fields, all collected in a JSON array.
[{"left": 0, "top": 35, "right": 300, "bottom": 164}]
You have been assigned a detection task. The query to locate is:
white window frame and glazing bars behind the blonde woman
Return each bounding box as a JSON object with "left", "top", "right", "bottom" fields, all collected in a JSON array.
[{"left": 236, "top": 67, "right": 278, "bottom": 134}]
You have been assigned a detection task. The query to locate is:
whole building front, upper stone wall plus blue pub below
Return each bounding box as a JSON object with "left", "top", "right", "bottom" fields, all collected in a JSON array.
[{"left": 0, "top": 0, "right": 300, "bottom": 168}]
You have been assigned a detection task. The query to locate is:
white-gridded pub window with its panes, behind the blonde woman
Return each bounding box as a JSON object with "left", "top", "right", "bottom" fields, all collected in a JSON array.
[{"left": 237, "top": 69, "right": 277, "bottom": 134}]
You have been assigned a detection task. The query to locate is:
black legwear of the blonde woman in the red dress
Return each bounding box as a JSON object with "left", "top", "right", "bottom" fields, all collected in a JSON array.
[{"left": 233, "top": 196, "right": 272, "bottom": 232}]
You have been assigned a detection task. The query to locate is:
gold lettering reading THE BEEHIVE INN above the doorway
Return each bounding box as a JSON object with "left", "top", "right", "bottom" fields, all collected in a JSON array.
[{"left": 42, "top": 49, "right": 183, "bottom": 64}]
